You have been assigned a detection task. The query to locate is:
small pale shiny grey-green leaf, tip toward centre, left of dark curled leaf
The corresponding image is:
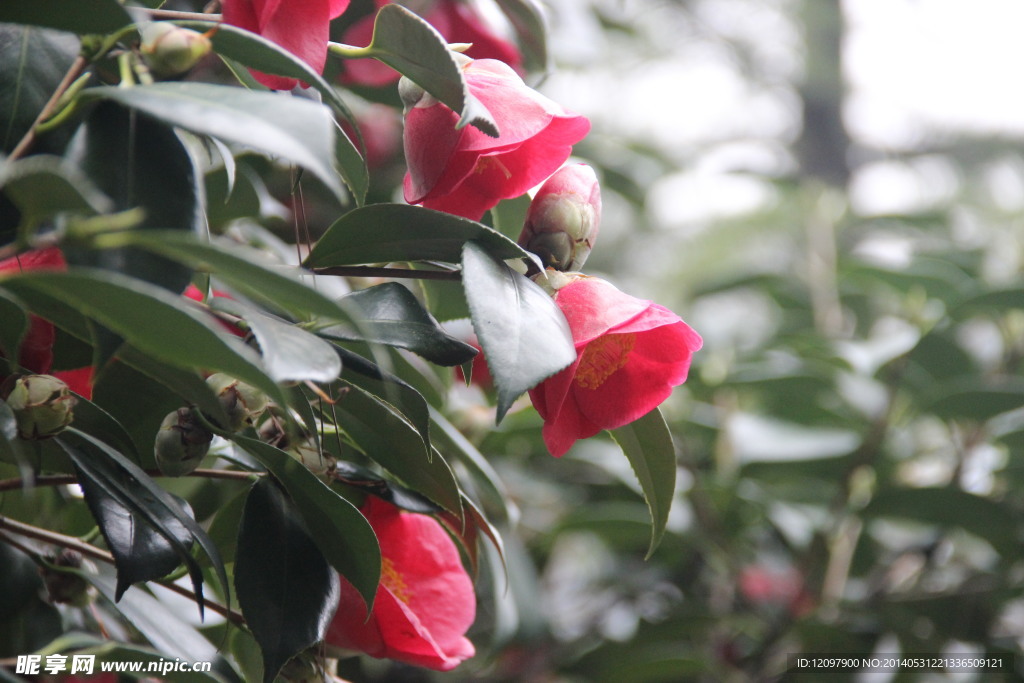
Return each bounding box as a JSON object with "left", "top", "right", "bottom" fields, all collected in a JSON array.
[{"left": 217, "top": 299, "right": 341, "bottom": 383}]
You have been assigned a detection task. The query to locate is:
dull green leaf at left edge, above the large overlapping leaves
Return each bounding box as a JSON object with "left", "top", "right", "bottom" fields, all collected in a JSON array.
[{"left": 0, "top": 155, "right": 114, "bottom": 224}]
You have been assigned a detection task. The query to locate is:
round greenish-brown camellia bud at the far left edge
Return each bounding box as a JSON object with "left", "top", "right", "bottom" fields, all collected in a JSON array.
[{"left": 3, "top": 375, "right": 78, "bottom": 440}]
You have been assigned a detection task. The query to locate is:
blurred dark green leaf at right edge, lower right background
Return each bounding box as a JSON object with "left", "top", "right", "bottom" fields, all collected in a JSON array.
[{"left": 863, "top": 487, "right": 1024, "bottom": 558}]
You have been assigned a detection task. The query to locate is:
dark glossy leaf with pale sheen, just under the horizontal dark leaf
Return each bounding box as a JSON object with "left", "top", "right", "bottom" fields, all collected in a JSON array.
[{"left": 321, "top": 283, "right": 476, "bottom": 367}]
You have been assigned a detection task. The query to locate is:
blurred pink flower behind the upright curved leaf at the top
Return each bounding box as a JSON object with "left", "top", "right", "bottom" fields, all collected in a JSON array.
[{"left": 341, "top": 0, "right": 522, "bottom": 88}]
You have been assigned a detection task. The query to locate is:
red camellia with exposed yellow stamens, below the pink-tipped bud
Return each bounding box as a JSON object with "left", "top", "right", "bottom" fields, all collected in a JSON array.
[{"left": 529, "top": 275, "right": 701, "bottom": 457}]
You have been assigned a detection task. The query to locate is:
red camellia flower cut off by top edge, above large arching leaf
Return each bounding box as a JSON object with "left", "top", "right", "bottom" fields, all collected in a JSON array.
[{"left": 222, "top": 0, "right": 349, "bottom": 90}]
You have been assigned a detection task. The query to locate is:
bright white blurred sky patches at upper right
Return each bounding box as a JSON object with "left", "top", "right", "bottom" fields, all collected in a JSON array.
[{"left": 546, "top": 0, "right": 1024, "bottom": 229}]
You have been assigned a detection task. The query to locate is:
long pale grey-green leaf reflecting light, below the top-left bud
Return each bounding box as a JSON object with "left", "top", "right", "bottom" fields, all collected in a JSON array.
[{"left": 82, "top": 83, "right": 345, "bottom": 202}]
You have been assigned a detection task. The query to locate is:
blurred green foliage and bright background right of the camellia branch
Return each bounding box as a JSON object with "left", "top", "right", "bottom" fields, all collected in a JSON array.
[{"left": 428, "top": 0, "right": 1024, "bottom": 682}]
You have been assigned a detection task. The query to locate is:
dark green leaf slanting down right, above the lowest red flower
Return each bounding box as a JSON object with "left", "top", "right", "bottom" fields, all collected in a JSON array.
[{"left": 334, "top": 385, "right": 462, "bottom": 513}]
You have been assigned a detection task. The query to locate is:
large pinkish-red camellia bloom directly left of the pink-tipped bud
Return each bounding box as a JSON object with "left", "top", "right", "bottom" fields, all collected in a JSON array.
[{"left": 403, "top": 59, "right": 590, "bottom": 220}]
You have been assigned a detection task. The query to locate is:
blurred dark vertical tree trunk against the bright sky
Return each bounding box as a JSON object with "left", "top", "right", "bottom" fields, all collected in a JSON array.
[{"left": 797, "top": 0, "right": 850, "bottom": 188}]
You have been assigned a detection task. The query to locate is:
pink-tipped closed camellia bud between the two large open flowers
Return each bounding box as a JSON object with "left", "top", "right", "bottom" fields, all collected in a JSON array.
[{"left": 519, "top": 164, "right": 601, "bottom": 270}]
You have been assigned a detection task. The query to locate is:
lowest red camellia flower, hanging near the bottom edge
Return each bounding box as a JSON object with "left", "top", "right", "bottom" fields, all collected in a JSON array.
[{"left": 325, "top": 496, "right": 476, "bottom": 671}]
